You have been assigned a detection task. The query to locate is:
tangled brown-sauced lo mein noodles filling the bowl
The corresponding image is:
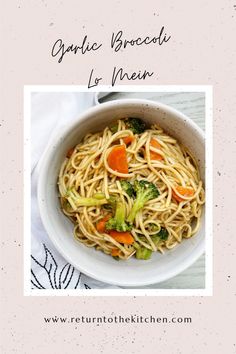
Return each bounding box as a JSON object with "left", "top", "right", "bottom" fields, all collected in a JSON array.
[{"left": 58, "top": 120, "right": 205, "bottom": 259}]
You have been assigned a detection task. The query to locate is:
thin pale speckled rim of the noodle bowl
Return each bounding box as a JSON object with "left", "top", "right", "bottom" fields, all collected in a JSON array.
[{"left": 37, "top": 98, "right": 205, "bottom": 287}]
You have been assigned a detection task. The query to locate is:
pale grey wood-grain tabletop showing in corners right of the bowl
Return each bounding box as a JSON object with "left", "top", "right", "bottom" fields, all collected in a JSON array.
[{"left": 102, "top": 92, "right": 205, "bottom": 289}]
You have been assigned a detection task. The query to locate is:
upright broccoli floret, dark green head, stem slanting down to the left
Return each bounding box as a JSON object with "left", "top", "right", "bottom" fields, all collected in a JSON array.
[{"left": 127, "top": 180, "right": 159, "bottom": 223}]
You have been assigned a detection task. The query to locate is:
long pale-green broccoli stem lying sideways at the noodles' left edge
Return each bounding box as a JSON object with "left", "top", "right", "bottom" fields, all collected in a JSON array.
[{"left": 65, "top": 188, "right": 108, "bottom": 210}]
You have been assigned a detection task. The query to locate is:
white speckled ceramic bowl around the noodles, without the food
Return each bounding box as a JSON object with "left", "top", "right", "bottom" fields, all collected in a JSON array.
[{"left": 38, "top": 99, "right": 205, "bottom": 287}]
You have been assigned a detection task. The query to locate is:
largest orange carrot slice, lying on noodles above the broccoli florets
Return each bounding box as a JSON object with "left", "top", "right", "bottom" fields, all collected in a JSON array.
[{"left": 107, "top": 145, "right": 129, "bottom": 173}]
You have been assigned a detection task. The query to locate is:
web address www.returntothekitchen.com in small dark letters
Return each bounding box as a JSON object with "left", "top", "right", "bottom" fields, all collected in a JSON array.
[{"left": 43, "top": 315, "right": 192, "bottom": 325}]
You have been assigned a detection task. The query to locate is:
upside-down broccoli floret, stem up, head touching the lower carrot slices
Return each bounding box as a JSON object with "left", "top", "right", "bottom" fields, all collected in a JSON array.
[{"left": 106, "top": 200, "right": 132, "bottom": 232}]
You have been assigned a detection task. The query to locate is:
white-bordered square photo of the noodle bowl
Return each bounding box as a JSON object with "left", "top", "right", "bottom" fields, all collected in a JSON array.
[{"left": 24, "top": 86, "right": 212, "bottom": 296}]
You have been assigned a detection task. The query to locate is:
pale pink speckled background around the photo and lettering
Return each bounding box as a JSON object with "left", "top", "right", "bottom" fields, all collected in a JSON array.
[{"left": 0, "top": 0, "right": 236, "bottom": 354}]
